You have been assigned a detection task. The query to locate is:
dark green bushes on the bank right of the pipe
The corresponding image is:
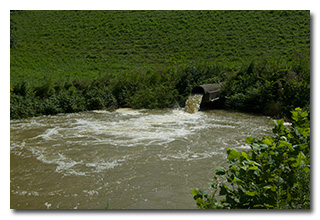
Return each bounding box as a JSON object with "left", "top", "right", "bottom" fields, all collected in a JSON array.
[{"left": 221, "top": 54, "right": 310, "bottom": 117}]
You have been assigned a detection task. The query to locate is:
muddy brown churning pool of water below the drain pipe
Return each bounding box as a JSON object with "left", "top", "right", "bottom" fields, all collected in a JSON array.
[{"left": 10, "top": 109, "right": 271, "bottom": 209}]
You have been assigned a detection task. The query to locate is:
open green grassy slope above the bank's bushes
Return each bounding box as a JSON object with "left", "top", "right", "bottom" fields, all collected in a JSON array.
[{"left": 10, "top": 11, "right": 310, "bottom": 83}]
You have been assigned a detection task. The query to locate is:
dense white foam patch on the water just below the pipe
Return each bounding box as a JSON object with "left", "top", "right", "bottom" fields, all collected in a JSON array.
[{"left": 68, "top": 109, "right": 207, "bottom": 146}]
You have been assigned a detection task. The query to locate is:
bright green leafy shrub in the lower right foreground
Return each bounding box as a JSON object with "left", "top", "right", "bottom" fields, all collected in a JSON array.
[{"left": 191, "top": 108, "right": 310, "bottom": 209}]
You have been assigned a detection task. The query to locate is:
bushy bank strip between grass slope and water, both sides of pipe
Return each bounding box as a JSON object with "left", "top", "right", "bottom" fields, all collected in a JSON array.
[{"left": 10, "top": 55, "right": 310, "bottom": 119}]
